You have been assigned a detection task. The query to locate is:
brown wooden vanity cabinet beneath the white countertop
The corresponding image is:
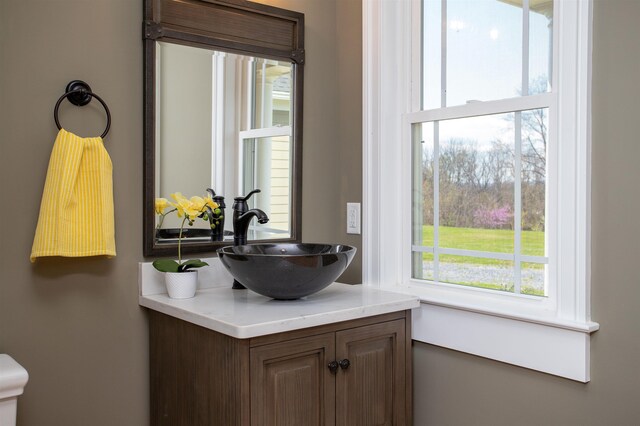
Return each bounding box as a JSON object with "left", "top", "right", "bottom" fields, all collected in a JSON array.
[{"left": 149, "top": 311, "right": 411, "bottom": 426}]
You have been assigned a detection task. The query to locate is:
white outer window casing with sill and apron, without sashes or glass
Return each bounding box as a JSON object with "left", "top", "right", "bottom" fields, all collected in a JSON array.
[{"left": 363, "top": 0, "right": 599, "bottom": 382}]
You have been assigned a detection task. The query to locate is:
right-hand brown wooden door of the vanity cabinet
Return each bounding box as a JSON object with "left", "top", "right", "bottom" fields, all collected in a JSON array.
[{"left": 336, "top": 320, "right": 407, "bottom": 426}]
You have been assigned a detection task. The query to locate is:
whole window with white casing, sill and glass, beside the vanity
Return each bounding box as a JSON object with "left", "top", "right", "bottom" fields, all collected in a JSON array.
[{"left": 363, "top": 0, "right": 598, "bottom": 381}]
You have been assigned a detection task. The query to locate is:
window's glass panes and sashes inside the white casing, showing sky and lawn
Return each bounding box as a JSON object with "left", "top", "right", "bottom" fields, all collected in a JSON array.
[{"left": 409, "top": 0, "right": 556, "bottom": 296}]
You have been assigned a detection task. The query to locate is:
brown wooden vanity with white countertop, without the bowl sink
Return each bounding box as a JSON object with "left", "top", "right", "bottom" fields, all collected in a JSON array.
[{"left": 140, "top": 276, "right": 419, "bottom": 426}]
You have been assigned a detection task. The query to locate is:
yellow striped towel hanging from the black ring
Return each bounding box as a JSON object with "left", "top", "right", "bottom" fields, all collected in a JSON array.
[{"left": 31, "top": 129, "right": 116, "bottom": 262}]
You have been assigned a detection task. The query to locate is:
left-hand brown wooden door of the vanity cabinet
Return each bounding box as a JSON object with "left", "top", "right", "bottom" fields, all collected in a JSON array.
[{"left": 250, "top": 333, "right": 335, "bottom": 426}]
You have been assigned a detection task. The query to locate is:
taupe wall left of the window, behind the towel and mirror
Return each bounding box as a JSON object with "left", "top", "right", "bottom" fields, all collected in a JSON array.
[{"left": 0, "top": 0, "right": 361, "bottom": 426}]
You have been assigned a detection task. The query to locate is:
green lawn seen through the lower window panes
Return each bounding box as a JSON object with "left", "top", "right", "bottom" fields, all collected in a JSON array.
[{"left": 422, "top": 226, "right": 544, "bottom": 265}]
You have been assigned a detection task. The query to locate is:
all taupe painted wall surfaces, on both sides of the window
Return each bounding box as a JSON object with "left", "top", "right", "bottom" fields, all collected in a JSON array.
[{"left": 0, "top": 0, "right": 640, "bottom": 426}]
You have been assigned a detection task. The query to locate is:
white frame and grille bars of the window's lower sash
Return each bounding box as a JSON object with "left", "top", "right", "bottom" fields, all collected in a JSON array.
[{"left": 400, "top": 104, "right": 558, "bottom": 302}]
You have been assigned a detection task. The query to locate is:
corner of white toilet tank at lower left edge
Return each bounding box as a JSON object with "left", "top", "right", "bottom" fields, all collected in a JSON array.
[{"left": 0, "top": 354, "right": 29, "bottom": 426}]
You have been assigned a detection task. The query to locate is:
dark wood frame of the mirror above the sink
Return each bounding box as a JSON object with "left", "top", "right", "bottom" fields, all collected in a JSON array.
[{"left": 143, "top": 0, "right": 305, "bottom": 256}]
